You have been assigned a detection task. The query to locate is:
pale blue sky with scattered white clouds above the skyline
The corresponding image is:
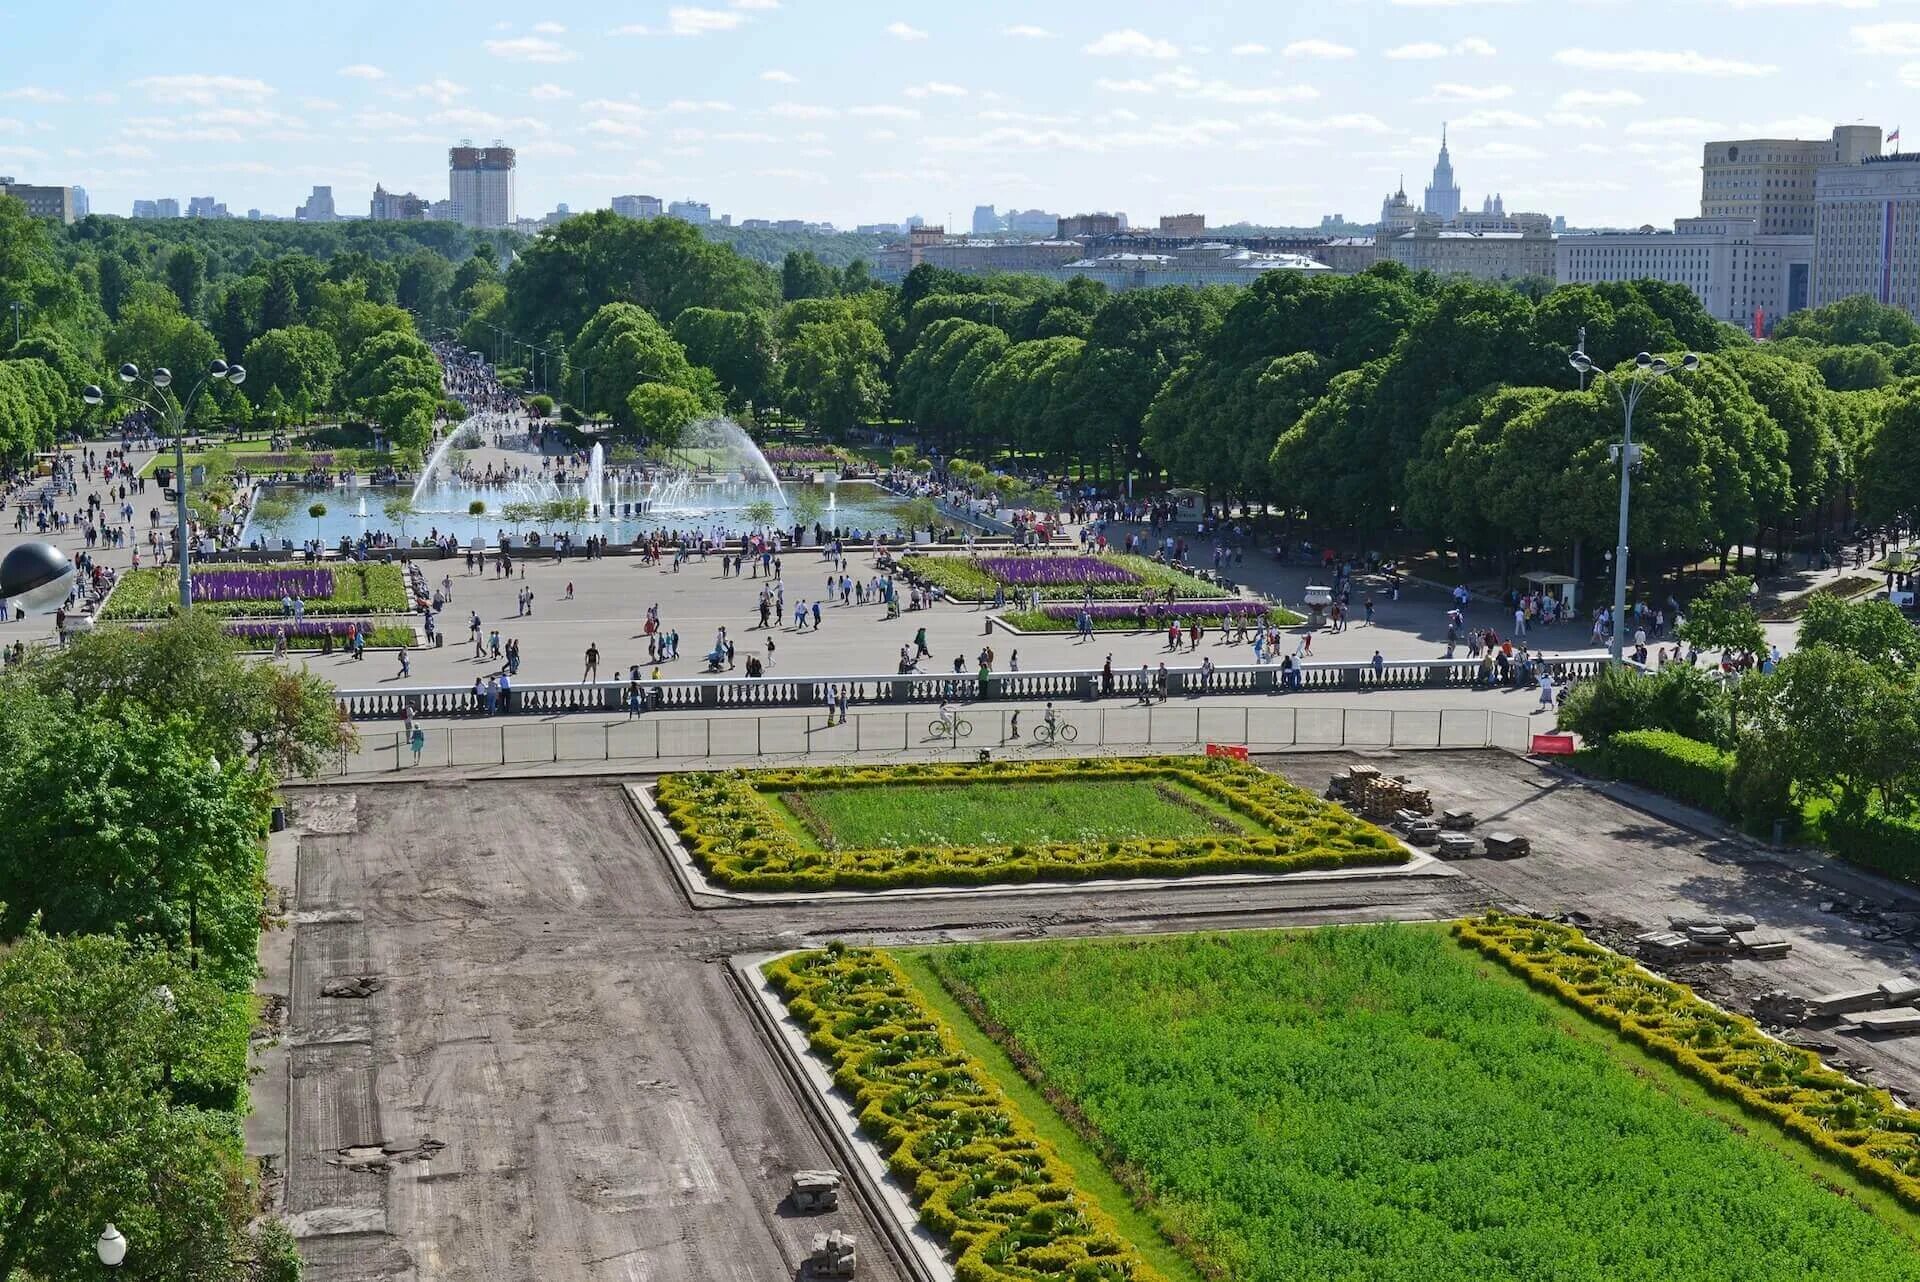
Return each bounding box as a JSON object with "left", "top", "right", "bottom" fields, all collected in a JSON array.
[{"left": 0, "top": 0, "right": 1920, "bottom": 228}]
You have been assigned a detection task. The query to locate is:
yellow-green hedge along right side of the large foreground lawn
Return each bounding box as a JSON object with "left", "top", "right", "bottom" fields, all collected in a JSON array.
[{"left": 1453, "top": 914, "right": 1920, "bottom": 1207}]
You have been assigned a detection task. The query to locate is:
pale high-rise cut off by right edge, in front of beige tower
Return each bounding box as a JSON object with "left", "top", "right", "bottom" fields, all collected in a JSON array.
[{"left": 1812, "top": 152, "right": 1920, "bottom": 319}]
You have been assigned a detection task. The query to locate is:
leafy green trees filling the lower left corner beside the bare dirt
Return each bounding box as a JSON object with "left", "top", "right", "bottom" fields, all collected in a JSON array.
[{"left": 0, "top": 614, "right": 351, "bottom": 1282}]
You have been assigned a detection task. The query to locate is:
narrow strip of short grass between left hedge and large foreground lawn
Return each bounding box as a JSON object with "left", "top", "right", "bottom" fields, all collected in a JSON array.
[{"left": 887, "top": 948, "right": 1204, "bottom": 1282}]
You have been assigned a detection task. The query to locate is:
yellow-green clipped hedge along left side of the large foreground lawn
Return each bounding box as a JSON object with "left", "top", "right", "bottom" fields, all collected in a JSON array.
[{"left": 764, "top": 948, "right": 1164, "bottom": 1282}]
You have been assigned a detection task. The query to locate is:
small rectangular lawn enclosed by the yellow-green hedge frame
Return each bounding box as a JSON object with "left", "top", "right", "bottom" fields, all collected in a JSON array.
[{"left": 776, "top": 779, "right": 1256, "bottom": 850}]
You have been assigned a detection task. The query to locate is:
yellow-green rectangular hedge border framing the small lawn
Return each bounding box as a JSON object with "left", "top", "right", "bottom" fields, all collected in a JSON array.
[{"left": 657, "top": 756, "right": 1407, "bottom": 890}]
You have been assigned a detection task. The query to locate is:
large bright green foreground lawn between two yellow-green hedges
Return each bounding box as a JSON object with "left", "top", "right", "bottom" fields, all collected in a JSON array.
[{"left": 912, "top": 925, "right": 1920, "bottom": 1282}]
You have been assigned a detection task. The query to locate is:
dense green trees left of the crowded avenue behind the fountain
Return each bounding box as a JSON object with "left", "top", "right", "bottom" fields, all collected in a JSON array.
[{"left": 0, "top": 200, "right": 487, "bottom": 461}]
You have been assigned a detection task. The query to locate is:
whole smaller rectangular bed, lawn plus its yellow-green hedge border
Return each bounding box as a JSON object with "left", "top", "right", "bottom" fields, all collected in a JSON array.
[{"left": 657, "top": 756, "right": 1407, "bottom": 890}]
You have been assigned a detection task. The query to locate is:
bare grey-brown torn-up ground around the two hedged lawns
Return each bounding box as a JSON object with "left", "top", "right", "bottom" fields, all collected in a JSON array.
[{"left": 274, "top": 750, "right": 1920, "bottom": 1282}]
